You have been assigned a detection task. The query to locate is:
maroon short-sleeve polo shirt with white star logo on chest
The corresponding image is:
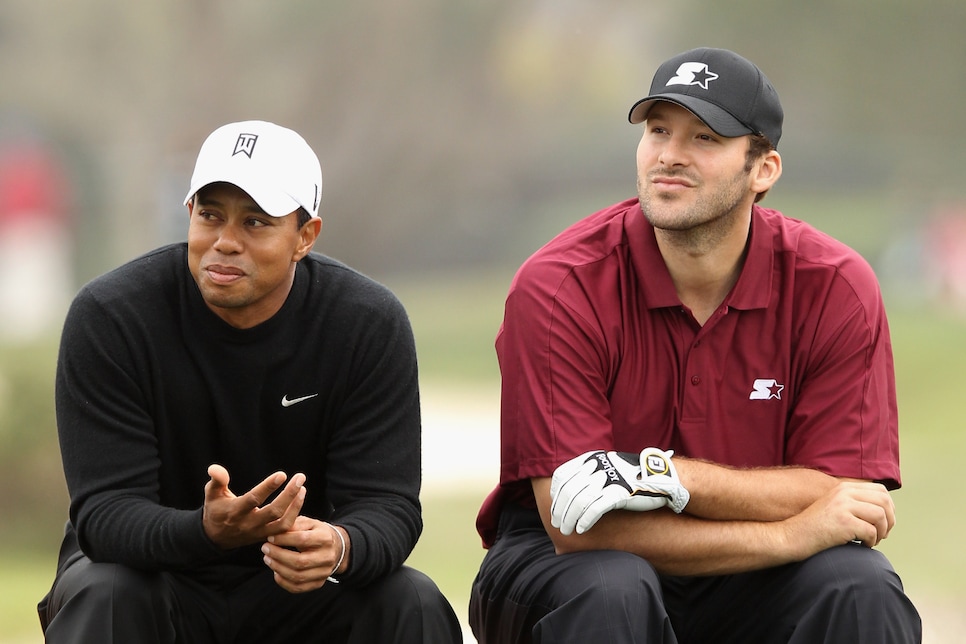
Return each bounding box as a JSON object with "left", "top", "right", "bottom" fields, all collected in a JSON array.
[{"left": 477, "top": 199, "right": 900, "bottom": 546}]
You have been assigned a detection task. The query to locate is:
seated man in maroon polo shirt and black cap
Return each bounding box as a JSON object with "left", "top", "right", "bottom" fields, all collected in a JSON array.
[{"left": 470, "top": 49, "right": 921, "bottom": 644}]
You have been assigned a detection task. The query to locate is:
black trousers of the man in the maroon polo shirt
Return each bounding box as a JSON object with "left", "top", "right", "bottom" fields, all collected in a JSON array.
[{"left": 469, "top": 508, "right": 922, "bottom": 644}]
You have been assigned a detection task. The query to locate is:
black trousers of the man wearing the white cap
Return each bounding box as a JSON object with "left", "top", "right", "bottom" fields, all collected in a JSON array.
[{"left": 38, "top": 528, "right": 463, "bottom": 644}]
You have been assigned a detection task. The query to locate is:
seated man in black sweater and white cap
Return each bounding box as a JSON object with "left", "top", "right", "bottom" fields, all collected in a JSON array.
[{"left": 39, "top": 121, "right": 462, "bottom": 644}]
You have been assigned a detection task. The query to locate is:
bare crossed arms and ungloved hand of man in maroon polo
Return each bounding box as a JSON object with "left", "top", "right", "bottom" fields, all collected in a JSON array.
[{"left": 531, "top": 458, "right": 895, "bottom": 575}]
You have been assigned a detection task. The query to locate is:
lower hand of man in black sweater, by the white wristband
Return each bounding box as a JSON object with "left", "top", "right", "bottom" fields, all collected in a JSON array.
[{"left": 262, "top": 516, "right": 351, "bottom": 593}]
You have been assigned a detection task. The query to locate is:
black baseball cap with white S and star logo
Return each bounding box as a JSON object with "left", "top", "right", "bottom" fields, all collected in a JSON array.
[{"left": 627, "top": 47, "right": 784, "bottom": 147}]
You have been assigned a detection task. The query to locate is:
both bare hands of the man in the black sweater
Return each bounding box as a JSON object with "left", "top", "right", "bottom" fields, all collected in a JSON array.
[{"left": 202, "top": 465, "right": 348, "bottom": 593}]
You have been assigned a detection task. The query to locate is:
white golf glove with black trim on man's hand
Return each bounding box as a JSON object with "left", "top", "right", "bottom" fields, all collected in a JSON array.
[{"left": 550, "top": 447, "right": 691, "bottom": 535}]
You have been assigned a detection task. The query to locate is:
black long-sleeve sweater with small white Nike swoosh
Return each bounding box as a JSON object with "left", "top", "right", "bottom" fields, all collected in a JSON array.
[{"left": 56, "top": 243, "right": 422, "bottom": 585}]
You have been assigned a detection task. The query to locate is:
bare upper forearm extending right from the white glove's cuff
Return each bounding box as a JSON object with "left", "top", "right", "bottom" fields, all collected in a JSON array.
[{"left": 674, "top": 458, "right": 838, "bottom": 521}]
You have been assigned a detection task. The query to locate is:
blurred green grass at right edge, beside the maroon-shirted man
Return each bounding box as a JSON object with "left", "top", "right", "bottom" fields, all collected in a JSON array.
[{"left": 882, "top": 308, "right": 966, "bottom": 602}]
